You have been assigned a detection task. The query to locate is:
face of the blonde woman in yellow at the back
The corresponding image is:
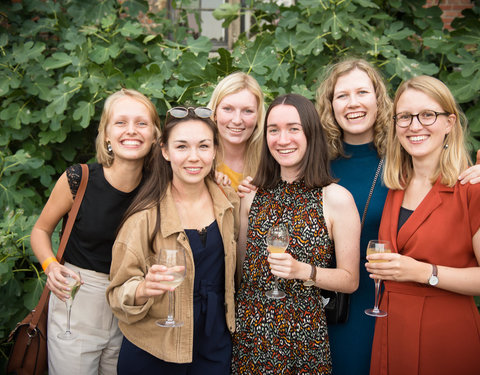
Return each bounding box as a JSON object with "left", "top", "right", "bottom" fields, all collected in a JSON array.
[{"left": 215, "top": 89, "right": 258, "bottom": 147}]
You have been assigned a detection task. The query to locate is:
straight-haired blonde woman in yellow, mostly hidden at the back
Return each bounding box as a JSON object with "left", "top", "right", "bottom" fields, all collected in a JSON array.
[{"left": 208, "top": 72, "right": 265, "bottom": 190}]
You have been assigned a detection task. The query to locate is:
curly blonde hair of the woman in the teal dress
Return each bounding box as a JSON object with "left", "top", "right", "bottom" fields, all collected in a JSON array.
[{"left": 315, "top": 58, "right": 392, "bottom": 159}]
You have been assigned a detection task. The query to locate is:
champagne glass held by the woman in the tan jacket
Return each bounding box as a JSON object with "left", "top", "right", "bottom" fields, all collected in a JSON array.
[{"left": 156, "top": 249, "right": 187, "bottom": 327}]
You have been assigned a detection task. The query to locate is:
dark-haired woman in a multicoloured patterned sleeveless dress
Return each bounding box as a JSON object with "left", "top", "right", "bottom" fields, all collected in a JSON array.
[{"left": 232, "top": 94, "right": 360, "bottom": 375}]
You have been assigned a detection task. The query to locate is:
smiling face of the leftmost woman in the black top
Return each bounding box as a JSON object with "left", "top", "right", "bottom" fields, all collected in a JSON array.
[{"left": 105, "top": 96, "right": 155, "bottom": 163}]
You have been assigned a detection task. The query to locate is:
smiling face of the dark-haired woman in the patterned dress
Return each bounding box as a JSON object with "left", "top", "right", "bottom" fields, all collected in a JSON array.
[{"left": 266, "top": 104, "right": 307, "bottom": 182}]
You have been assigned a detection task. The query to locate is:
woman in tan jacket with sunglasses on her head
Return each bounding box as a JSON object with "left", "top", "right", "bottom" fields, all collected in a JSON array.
[{"left": 107, "top": 107, "right": 239, "bottom": 375}]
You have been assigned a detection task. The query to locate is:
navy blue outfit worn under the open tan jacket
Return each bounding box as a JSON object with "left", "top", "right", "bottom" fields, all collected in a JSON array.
[{"left": 118, "top": 221, "right": 232, "bottom": 375}]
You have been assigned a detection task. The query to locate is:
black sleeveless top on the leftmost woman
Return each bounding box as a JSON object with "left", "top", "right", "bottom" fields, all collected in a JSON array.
[{"left": 64, "top": 163, "right": 142, "bottom": 274}]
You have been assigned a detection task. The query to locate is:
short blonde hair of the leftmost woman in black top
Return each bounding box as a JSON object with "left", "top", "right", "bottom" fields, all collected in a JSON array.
[{"left": 95, "top": 89, "right": 161, "bottom": 167}]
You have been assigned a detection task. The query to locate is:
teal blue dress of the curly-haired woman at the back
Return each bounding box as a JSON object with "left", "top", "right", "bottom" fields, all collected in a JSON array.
[{"left": 328, "top": 143, "right": 388, "bottom": 375}]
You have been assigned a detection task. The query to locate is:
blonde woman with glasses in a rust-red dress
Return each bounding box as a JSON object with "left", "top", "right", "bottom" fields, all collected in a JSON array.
[{"left": 366, "top": 76, "right": 480, "bottom": 375}]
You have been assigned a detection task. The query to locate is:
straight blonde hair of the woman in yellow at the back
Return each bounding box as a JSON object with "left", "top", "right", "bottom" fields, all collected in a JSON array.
[{"left": 208, "top": 72, "right": 265, "bottom": 181}]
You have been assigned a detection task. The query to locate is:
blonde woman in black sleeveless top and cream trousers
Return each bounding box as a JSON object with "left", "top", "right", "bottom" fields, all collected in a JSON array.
[{"left": 31, "top": 89, "right": 160, "bottom": 375}]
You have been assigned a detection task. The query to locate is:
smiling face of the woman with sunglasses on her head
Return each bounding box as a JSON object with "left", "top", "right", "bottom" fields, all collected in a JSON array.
[{"left": 162, "top": 120, "right": 216, "bottom": 185}]
